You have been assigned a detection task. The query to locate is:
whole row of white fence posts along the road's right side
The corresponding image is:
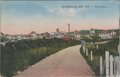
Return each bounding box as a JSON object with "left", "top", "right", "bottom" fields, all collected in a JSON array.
[{"left": 82, "top": 45, "right": 117, "bottom": 77}]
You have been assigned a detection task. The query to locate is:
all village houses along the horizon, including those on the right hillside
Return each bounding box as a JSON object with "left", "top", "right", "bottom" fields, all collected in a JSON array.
[{"left": 0, "top": 28, "right": 117, "bottom": 42}]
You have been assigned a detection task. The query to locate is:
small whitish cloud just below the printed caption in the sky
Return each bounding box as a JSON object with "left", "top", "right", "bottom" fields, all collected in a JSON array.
[{"left": 50, "top": 8, "right": 77, "bottom": 17}]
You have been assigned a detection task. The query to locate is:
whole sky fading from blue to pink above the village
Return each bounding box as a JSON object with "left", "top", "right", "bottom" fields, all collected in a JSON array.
[{"left": 1, "top": 1, "right": 119, "bottom": 34}]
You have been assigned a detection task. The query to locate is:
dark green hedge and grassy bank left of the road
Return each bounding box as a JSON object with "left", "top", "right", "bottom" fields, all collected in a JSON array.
[{"left": 0, "top": 39, "right": 80, "bottom": 77}]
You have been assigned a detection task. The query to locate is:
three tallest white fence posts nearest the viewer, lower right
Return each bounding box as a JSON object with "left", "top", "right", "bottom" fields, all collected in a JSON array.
[{"left": 100, "top": 51, "right": 114, "bottom": 77}]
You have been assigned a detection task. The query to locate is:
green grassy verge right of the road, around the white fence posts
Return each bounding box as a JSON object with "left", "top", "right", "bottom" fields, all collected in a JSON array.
[{"left": 80, "top": 38, "right": 118, "bottom": 76}]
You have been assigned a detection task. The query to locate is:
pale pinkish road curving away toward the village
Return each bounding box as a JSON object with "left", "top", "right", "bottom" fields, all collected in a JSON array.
[{"left": 14, "top": 45, "right": 94, "bottom": 77}]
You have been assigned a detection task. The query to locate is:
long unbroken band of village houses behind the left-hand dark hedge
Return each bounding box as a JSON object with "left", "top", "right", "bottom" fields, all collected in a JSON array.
[{"left": 0, "top": 28, "right": 80, "bottom": 42}]
